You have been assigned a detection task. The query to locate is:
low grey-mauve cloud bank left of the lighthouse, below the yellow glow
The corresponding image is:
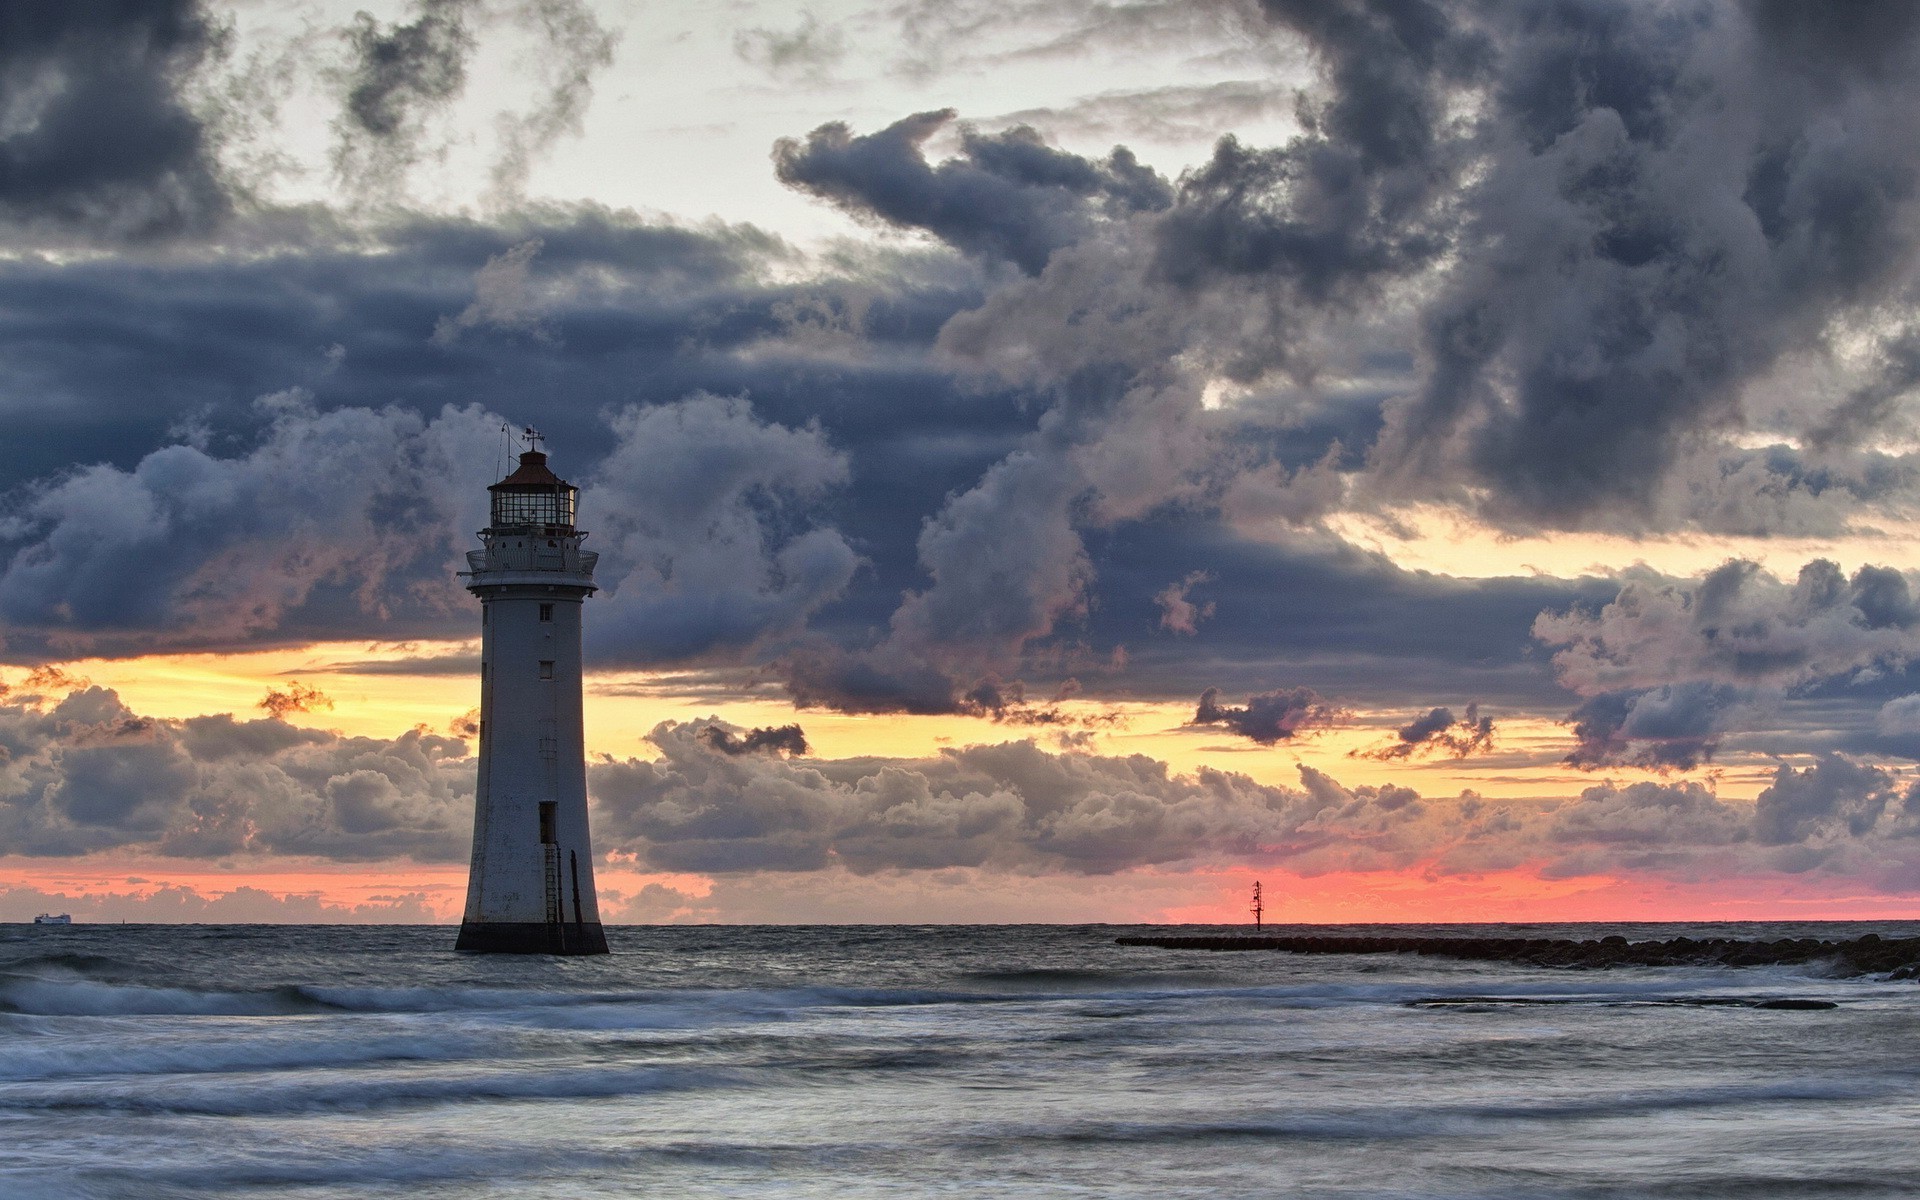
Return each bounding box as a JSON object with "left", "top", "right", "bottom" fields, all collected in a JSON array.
[{"left": 0, "top": 687, "right": 472, "bottom": 862}]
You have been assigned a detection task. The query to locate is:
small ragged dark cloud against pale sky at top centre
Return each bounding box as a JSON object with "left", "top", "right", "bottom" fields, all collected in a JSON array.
[{"left": 774, "top": 109, "right": 1171, "bottom": 275}]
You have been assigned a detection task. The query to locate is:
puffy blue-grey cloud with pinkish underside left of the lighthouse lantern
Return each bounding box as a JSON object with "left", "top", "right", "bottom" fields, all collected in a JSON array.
[{"left": 0, "top": 394, "right": 499, "bottom": 653}]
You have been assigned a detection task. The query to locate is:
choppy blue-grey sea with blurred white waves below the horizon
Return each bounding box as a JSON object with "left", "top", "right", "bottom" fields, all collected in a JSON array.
[{"left": 0, "top": 922, "right": 1920, "bottom": 1198}]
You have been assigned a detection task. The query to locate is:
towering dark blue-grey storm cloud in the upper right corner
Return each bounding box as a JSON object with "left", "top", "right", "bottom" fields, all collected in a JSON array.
[{"left": 1379, "top": 2, "right": 1920, "bottom": 528}]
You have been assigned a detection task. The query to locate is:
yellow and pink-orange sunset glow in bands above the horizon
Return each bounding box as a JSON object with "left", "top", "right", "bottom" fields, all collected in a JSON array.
[{"left": 0, "top": 641, "right": 1920, "bottom": 924}]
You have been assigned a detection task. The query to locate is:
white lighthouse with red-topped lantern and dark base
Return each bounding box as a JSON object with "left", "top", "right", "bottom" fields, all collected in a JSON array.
[{"left": 455, "top": 430, "right": 607, "bottom": 954}]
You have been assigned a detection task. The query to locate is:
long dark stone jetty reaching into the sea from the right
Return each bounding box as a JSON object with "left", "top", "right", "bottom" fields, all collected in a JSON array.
[{"left": 1114, "top": 933, "right": 1920, "bottom": 979}]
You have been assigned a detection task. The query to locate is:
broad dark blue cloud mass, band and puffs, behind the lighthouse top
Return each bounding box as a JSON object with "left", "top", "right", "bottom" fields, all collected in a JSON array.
[{"left": 0, "top": 209, "right": 1031, "bottom": 662}]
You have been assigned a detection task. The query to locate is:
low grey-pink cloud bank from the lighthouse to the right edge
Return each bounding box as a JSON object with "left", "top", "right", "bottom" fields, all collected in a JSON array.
[{"left": 591, "top": 722, "right": 1920, "bottom": 885}]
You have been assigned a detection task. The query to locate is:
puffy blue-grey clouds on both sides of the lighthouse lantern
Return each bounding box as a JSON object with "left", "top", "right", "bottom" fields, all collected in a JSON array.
[{"left": 0, "top": 372, "right": 860, "bottom": 662}]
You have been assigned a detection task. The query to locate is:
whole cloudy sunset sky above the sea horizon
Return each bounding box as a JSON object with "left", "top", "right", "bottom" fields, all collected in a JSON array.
[{"left": 11, "top": 0, "right": 1920, "bottom": 922}]
